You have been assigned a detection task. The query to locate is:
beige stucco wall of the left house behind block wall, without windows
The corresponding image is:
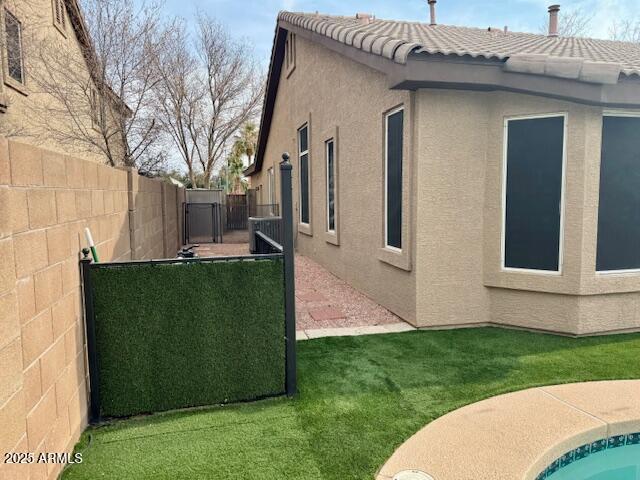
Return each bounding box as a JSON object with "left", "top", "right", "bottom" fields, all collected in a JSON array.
[{"left": 0, "top": 0, "right": 124, "bottom": 163}]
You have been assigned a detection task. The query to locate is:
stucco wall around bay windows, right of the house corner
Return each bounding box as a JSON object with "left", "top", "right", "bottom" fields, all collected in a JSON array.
[{"left": 416, "top": 90, "right": 640, "bottom": 334}]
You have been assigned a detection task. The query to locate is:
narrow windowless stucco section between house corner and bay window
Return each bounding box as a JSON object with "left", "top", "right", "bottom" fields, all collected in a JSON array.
[{"left": 416, "top": 90, "right": 490, "bottom": 327}]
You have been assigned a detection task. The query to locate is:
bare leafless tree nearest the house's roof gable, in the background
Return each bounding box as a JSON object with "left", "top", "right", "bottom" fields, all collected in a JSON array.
[{"left": 156, "top": 13, "right": 264, "bottom": 186}]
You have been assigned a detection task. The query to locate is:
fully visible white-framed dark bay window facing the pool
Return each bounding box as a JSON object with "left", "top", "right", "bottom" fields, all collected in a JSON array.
[{"left": 503, "top": 115, "right": 566, "bottom": 272}]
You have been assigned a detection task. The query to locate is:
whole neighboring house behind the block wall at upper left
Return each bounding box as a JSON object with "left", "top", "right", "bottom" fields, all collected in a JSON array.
[{"left": 0, "top": 0, "right": 128, "bottom": 162}]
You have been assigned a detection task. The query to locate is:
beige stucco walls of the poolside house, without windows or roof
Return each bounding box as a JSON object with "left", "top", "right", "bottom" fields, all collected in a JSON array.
[{"left": 252, "top": 30, "right": 640, "bottom": 335}]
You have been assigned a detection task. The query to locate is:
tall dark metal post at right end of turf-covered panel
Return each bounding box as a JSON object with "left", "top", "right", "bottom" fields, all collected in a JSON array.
[{"left": 280, "top": 153, "right": 297, "bottom": 396}]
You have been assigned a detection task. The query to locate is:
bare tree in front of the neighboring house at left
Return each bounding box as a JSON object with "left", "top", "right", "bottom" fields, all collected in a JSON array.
[{"left": 26, "top": 0, "right": 168, "bottom": 171}]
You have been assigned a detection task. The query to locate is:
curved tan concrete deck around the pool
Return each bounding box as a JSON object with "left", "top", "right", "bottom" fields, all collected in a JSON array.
[{"left": 377, "top": 380, "right": 640, "bottom": 480}]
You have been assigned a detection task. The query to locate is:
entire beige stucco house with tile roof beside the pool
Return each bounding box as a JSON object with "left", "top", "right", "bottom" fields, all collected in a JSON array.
[{"left": 246, "top": 4, "right": 640, "bottom": 334}]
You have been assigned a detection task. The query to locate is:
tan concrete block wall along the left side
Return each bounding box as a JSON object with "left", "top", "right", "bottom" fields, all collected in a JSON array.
[{"left": 0, "top": 138, "right": 183, "bottom": 479}]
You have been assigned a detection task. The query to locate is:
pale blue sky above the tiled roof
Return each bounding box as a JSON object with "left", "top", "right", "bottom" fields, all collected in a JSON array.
[{"left": 149, "top": 0, "right": 640, "bottom": 64}]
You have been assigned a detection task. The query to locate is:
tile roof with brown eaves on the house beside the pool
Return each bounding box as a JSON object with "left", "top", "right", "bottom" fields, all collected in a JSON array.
[{"left": 244, "top": 12, "right": 640, "bottom": 175}]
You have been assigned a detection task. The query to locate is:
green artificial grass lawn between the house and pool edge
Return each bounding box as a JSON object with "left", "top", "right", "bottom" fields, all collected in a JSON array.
[{"left": 63, "top": 328, "right": 640, "bottom": 480}]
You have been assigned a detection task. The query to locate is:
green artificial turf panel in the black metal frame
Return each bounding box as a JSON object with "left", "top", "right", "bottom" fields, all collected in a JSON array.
[{"left": 91, "top": 258, "right": 285, "bottom": 418}]
